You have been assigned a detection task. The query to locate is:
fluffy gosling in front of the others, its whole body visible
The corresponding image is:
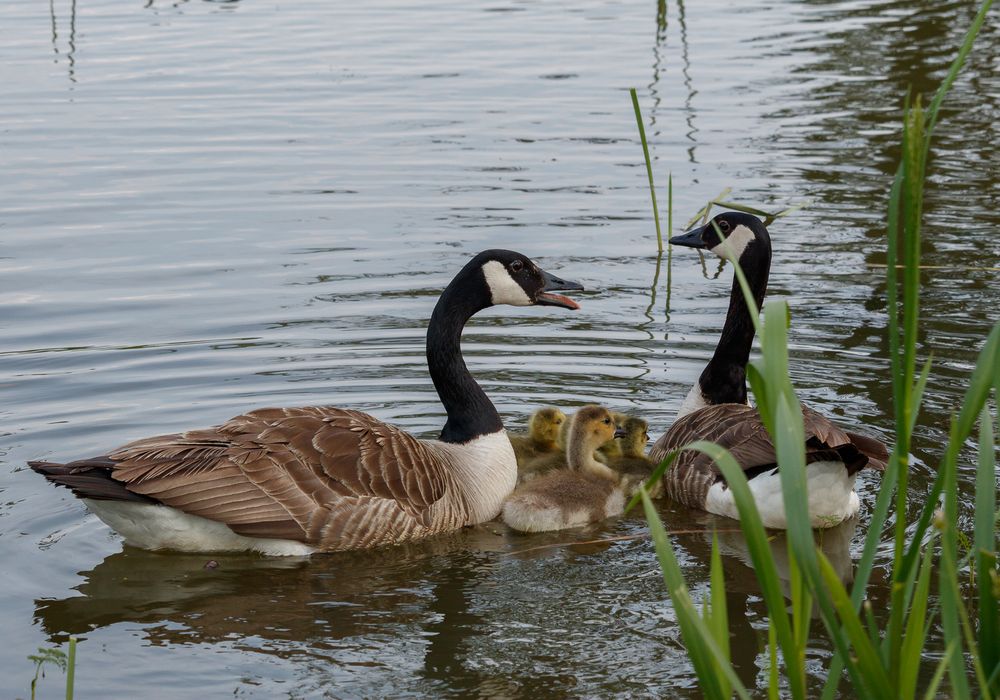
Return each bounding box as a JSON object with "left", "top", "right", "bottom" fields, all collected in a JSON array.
[{"left": 503, "top": 406, "right": 625, "bottom": 532}]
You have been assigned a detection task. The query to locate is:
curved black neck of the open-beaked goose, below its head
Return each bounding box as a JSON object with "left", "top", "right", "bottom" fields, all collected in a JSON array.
[{"left": 427, "top": 267, "right": 503, "bottom": 443}]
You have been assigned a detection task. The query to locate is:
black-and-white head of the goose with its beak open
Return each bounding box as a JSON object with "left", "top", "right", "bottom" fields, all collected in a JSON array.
[{"left": 468, "top": 249, "right": 583, "bottom": 309}]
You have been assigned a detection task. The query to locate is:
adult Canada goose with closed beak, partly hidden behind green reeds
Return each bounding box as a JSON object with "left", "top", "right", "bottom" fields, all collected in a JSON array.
[{"left": 649, "top": 212, "right": 888, "bottom": 529}]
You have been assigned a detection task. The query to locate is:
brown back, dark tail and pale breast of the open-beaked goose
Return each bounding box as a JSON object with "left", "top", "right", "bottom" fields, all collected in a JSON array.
[{"left": 32, "top": 406, "right": 515, "bottom": 551}]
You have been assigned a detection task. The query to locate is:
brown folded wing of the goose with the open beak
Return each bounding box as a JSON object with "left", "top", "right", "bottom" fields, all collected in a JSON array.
[{"left": 103, "top": 407, "right": 449, "bottom": 547}]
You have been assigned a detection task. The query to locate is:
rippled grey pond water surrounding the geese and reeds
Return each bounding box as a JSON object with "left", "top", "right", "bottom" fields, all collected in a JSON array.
[{"left": 0, "top": 0, "right": 1000, "bottom": 698}]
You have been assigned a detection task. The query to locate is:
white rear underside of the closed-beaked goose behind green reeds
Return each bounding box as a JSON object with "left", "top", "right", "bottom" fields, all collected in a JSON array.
[{"left": 705, "top": 462, "right": 860, "bottom": 530}]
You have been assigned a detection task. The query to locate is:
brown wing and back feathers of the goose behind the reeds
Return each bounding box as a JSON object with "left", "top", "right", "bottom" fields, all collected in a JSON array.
[{"left": 649, "top": 404, "right": 888, "bottom": 508}]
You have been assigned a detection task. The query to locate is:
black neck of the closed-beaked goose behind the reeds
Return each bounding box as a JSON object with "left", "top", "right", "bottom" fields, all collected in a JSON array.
[{"left": 698, "top": 234, "right": 771, "bottom": 404}]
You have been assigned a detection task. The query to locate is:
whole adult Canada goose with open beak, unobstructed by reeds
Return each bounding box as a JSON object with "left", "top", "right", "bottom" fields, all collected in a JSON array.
[{"left": 29, "top": 250, "right": 583, "bottom": 555}]
